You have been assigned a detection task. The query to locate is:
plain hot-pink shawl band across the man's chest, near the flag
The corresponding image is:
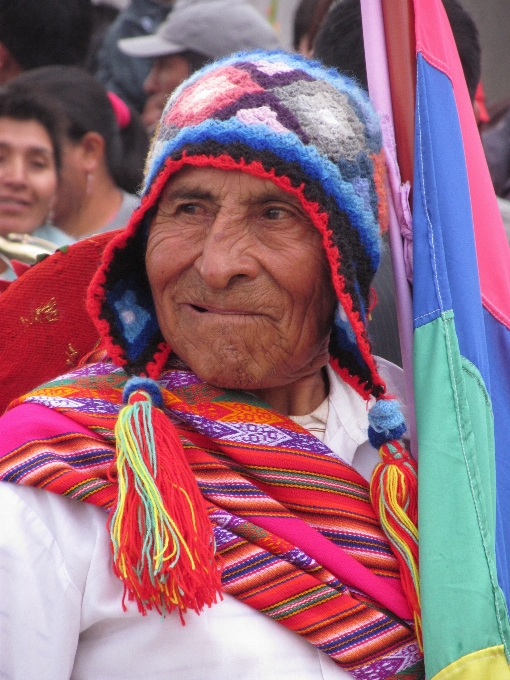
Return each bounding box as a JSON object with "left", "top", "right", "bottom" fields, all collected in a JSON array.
[{"left": 246, "top": 515, "right": 412, "bottom": 621}]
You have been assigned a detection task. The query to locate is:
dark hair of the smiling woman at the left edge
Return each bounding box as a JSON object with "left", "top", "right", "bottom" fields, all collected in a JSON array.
[{"left": 0, "top": 81, "right": 63, "bottom": 171}]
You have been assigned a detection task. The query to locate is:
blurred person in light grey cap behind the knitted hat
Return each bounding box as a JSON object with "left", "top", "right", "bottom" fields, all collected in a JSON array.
[{"left": 119, "top": 0, "right": 279, "bottom": 129}]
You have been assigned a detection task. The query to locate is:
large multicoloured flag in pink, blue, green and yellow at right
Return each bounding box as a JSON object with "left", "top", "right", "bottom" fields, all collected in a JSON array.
[{"left": 362, "top": 0, "right": 510, "bottom": 680}]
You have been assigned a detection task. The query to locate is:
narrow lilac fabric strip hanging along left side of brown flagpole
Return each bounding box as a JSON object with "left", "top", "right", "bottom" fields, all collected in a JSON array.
[{"left": 361, "top": 0, "right": 418, "bottom": 458}]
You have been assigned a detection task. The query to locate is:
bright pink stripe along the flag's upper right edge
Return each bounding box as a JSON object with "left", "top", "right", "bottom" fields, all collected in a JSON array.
[{"left": 414, "top": 0, "right": 510, "bottom": 329}]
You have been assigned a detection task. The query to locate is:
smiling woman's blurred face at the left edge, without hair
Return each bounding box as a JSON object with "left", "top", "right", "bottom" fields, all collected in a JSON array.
[{"left": 0, "top": 118, "right": 58, "bottom": 234}]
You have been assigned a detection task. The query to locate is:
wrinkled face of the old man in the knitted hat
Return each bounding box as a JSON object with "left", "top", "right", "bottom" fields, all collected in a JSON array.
[{"left": 146, "top": 168, "right": 335, "bottom": 389}]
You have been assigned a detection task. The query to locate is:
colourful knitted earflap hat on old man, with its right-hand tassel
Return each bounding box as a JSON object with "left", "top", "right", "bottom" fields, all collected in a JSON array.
[{"left": 88, "top": 51, "right": 419, "bottom": 636}]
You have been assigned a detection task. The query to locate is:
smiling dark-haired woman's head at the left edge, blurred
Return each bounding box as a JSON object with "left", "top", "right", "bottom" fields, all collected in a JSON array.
[{"left": 0, "top": 81, "right": 61, "bottom": 280}]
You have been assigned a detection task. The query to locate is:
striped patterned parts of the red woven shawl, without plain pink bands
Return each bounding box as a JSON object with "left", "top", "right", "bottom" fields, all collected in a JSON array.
[{"left": 0, "top": 364, "right": 422, "bottom": 680}]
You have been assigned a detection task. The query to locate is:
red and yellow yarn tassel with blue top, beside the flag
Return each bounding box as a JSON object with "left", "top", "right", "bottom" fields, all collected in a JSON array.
[{"left": 369, "top": 399, "right": 423, "bottom": 651}]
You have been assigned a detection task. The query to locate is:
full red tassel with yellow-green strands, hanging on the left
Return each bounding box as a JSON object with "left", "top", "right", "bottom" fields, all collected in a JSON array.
[{"left": 109, "top": 378, "right": 221, "bottom": 623}]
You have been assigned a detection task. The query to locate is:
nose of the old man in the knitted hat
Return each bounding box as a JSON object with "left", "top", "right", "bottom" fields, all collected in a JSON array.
[{"left": 195, "top": 215, "right": 260, "bottom": 290}]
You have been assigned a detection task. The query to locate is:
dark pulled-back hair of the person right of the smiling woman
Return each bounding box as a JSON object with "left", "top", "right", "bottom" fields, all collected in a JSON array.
[{"left": 13, "top": 66, "right": 122, "bottom": 182}]
